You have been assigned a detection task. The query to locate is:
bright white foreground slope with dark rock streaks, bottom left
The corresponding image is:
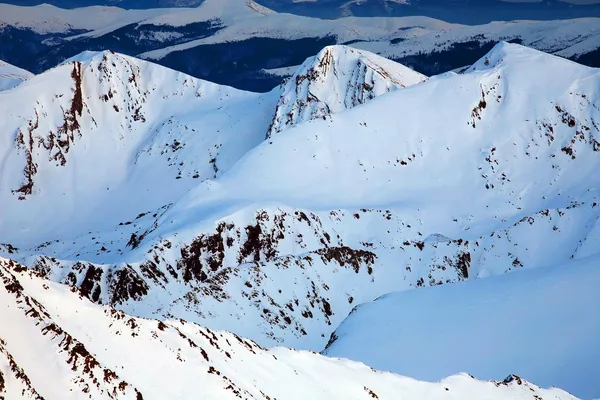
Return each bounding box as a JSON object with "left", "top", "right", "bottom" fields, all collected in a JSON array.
[{"left": 0, "top": 259, "right": 575, "bottom": 400}]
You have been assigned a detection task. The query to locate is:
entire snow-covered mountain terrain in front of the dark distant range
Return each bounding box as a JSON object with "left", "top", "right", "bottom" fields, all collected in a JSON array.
[{"left": 0, "top": 34, "right": 600, "bottom": 400}]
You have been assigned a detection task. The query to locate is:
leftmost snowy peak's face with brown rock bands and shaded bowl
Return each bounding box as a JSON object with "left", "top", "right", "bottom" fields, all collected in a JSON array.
[{"left": 0, "top": 52, "right": 276, "bottom": 244}]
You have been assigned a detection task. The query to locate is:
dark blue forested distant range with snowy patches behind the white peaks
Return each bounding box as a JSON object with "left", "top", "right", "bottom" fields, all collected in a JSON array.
[{"left": 0, "top": 0, "right": 600, "bottom": 91}]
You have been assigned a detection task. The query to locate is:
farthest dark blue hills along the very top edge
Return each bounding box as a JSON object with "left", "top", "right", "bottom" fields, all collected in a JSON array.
[{"left": 1, "top": 0, "right": 600, "bottom": 24}]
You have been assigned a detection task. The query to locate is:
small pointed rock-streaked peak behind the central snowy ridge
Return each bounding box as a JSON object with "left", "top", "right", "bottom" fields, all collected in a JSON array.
[{"left": 267, "top": 46, "right": 427, "bottom": 138}]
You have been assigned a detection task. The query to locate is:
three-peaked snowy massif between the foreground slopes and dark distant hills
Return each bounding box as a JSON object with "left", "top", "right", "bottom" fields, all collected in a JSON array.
[{"left": 0, "top": 42, "right": 600, "bottom": 396}]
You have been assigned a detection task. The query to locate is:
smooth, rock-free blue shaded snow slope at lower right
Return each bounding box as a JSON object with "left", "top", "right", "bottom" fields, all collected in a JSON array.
[{"left": 323, "top": 257, "right": 600, "bottom": 398}]
